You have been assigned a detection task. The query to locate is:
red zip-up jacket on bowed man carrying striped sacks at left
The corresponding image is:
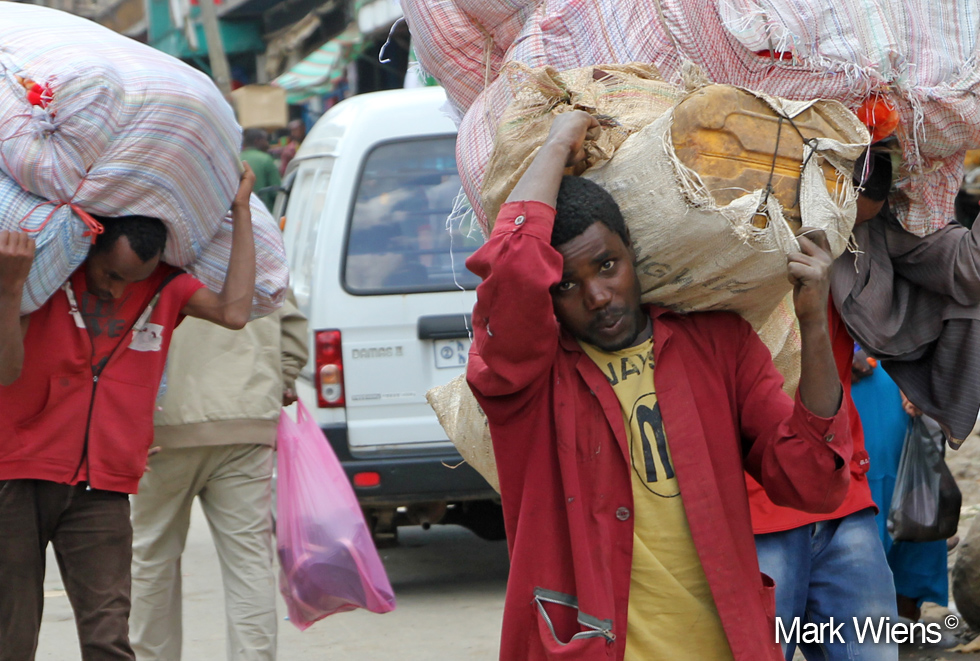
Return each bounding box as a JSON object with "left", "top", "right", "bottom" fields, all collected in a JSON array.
[{"left": 0, "top": 266, "right": 203, "bottom": 493}]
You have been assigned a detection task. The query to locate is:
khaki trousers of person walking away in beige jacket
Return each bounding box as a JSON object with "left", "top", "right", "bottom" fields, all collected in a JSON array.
[{"left": 130, "top": 445, "right": 277, "bottom": 661}]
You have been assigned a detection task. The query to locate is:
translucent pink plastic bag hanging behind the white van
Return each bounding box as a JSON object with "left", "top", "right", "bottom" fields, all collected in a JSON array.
[{"left": 276, "top": 401, "right": 395, "bottom": 631}]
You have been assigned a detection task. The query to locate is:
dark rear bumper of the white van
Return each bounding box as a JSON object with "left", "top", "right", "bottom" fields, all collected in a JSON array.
[{"left": 321, "top": 425, "right": 500, "bottom": 507}]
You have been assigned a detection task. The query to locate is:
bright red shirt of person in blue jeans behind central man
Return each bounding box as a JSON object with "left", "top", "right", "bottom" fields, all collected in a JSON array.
[{"left": 745, "top": 303, "right": 877, "bottom": 535}]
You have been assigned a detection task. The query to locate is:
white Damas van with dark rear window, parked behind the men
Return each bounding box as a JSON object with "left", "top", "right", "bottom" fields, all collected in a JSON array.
[{"left": 275, "top": 88, "right": 503, "bottom": 541}]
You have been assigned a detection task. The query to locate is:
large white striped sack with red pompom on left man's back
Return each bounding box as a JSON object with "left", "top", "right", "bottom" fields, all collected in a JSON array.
[{"left": 0, "top": 2, "right": 241, "bottom": 266}]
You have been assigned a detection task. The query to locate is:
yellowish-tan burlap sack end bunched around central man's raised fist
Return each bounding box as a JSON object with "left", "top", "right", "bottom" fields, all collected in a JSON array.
[{"left": 481, "top": 64, "right": 681, "bottom": 227}]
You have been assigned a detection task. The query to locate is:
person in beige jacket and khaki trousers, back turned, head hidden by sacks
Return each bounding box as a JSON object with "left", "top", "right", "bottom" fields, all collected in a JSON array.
[{"left": 132, "top": 296, "right": 307, "bottom": 661}]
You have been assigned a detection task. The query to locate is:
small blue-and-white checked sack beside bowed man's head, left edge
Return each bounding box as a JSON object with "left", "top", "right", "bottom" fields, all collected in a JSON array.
[{"left": 0, "top": 172, "right": 92, "bottom": 315}]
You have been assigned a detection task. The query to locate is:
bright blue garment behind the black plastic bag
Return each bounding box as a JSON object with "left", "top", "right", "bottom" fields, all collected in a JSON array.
[{"left": 851, "top": 367, "right": 949, "bottom": 606}]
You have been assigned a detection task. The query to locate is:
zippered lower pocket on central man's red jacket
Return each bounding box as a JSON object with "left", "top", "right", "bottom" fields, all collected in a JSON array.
[{"left": 534, "top": 588, "right": 616, "bottom": 659}]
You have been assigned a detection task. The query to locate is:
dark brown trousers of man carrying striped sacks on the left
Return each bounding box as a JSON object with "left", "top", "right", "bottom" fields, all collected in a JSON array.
[{"left": 0, "top": 480, "right": 135, "bottom": 661}]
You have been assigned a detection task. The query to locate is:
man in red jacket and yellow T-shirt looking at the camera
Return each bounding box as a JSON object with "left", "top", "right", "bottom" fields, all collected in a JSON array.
[{"left": 467, "top": 111, "right": 850, "bottom": 661}]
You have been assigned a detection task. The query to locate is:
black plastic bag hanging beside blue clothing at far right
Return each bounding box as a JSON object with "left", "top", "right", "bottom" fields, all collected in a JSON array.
[{"left": 888, "top": 416, "right": 963, "bottom": 542}]
